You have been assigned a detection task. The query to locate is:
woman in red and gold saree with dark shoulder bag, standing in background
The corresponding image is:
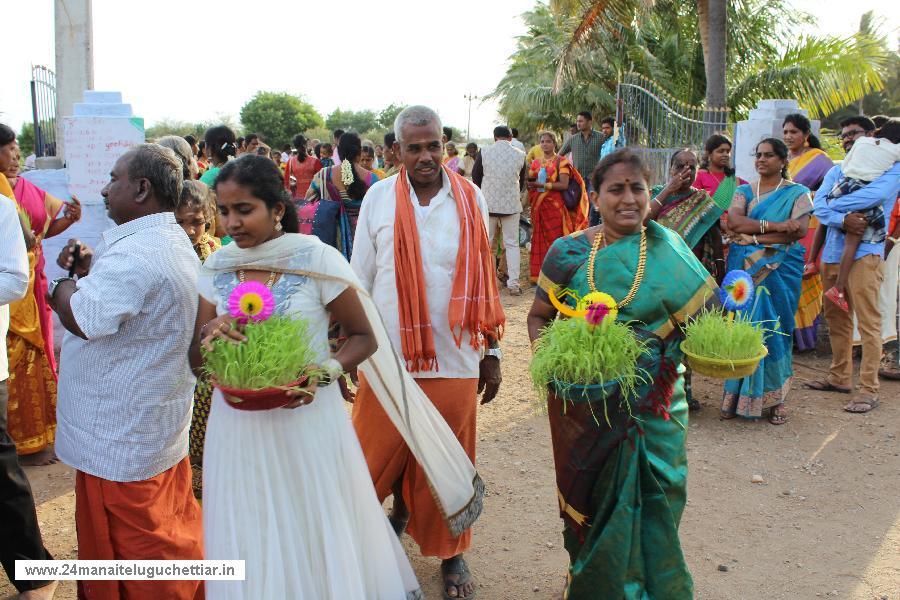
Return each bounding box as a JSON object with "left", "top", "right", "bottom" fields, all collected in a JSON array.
[{"left": 527, "top": 131, "right": 590, "bottom": 282}]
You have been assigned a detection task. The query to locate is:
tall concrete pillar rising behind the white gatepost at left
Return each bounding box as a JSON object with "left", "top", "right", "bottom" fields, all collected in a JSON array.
[{"left": 54, "top": 0, "right": 94, "bottom": 159}]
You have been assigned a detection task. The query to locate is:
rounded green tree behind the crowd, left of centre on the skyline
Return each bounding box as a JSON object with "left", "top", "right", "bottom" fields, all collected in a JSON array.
[{"left": 241, "top": 92, "right": 322, "bottom": 148}]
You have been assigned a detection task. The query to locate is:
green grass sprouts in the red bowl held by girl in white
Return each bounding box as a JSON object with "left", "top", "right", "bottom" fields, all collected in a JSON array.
[{"left": 203, "top": 315, "right": 318, "bottom": 390}]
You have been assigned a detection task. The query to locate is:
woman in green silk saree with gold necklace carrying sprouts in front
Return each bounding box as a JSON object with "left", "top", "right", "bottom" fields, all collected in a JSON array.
[{"left": 528, "top": 148, "right": 718, "bottom": 600}]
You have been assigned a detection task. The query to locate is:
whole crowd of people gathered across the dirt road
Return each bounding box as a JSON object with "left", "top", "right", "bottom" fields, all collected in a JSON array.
[{"left": 0, "top": 106, "right": 900, "bottom": 599}]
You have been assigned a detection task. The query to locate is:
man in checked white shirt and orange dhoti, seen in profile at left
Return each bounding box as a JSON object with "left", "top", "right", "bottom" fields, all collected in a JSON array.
[{"left": 48, "top": 144, "right": 203, "bottom": 599}]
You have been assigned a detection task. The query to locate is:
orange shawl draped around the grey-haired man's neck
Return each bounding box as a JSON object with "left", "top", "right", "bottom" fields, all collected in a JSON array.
[{"left": 394, "top": 166, "right": 506, "bottom": 372}]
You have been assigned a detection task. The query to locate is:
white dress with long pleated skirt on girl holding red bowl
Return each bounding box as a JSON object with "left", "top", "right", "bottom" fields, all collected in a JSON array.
[{"left": 198, "top": 243, "right": 423, "bottom": 600}]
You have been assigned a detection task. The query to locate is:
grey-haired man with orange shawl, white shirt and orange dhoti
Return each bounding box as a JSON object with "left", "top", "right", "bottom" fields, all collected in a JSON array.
[{"left": 350, "top": 106, "right": 505, "bottom": 598}]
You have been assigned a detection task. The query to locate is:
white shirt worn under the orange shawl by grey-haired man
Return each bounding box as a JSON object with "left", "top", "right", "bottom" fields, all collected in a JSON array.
[{"left": 350, "top": 173, "right": 488, "bottom": 379}]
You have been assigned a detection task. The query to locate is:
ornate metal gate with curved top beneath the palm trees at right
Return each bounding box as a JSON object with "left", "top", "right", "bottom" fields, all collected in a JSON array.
[{"left": 616, "top": 73, "right": 729, "bottom": 185}]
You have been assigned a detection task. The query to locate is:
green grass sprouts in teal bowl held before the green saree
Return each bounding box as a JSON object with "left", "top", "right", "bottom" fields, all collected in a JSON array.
[{"left": 531, "top": 318, "right": 646, "bottom": 423}]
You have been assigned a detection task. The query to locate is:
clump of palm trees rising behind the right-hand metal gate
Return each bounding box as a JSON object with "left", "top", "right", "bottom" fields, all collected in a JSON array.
[{"left": 494, "top": 0, "right": 896, "bottom": 122}]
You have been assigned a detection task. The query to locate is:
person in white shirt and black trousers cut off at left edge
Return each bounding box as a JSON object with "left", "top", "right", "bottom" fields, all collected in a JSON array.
[{"left": 0, "top": 185, "right": 57, "bottom": 600}]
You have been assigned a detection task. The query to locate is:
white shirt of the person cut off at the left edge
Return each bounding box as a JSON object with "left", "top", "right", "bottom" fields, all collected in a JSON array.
[{"left": 0, "top": 196, "right": 28, "bottom": 382}]
